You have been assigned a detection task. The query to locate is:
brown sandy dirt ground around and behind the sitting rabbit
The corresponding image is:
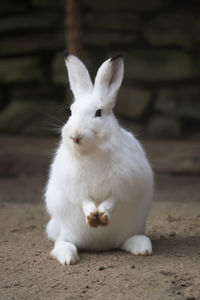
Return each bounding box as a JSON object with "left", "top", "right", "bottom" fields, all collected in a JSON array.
[{"left": 0, "top": 136, "right": 200, "bottom": 300}]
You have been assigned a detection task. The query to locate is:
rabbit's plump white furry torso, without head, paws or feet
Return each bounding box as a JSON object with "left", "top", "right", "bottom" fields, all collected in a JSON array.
[{"left": 47, "top": 124, "right": 153, "bottom": 250}]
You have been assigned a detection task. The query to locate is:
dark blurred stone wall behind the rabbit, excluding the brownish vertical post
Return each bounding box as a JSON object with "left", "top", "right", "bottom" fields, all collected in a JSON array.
[{"left": 0, "top": 0, "right": 200, "bottom": 138}]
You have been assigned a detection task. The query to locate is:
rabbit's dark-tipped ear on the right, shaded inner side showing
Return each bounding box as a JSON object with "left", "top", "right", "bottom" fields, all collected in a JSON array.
[{"left": 94, "top": 54, "right": 124, "bottom": 105}]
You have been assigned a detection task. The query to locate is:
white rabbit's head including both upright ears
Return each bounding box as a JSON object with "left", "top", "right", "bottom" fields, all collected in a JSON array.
[{"left": 62, "top": 54, "right": 124, "bottom": 153}]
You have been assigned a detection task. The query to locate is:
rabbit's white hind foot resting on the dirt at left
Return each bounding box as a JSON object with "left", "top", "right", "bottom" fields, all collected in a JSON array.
[{"left": 51, "top": 241, "right": 79, "bottom": 265}]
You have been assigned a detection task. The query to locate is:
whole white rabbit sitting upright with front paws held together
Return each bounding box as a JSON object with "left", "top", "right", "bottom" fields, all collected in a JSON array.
[{"left": 45, "top": 54, "right": 153, "bottom": 264}]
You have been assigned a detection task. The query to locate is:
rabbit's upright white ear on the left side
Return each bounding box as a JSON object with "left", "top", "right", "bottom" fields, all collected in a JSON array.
[{"left": 64, "top": 51, "right": 93, "bottom": 99}]
